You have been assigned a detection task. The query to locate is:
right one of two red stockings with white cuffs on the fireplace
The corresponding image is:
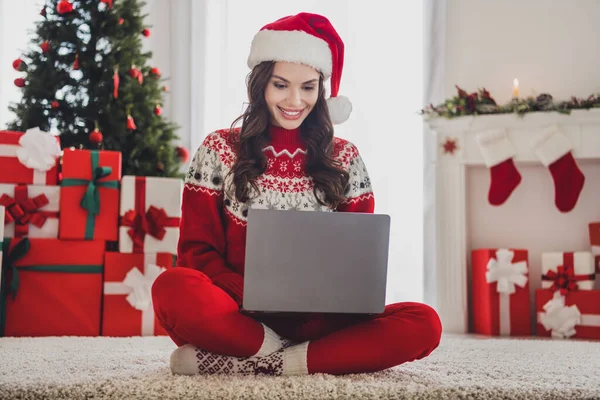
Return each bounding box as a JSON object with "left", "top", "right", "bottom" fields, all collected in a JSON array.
[{"left": 531, "top": 126, "right": 585, "bottom": 212}]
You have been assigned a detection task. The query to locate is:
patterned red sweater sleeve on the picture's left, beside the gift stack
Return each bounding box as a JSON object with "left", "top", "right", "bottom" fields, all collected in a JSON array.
[{"left": 177, "top": 133, "right": 244, "bottom": 305}]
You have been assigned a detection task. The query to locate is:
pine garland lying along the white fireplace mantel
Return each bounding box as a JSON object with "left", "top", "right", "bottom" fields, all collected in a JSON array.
[{"left": 419, "top": 85, "right": 600, "bottom": 119}]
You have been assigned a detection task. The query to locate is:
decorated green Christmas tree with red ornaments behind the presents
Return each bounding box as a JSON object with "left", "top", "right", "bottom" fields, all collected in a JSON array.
[{"left": 8, "top": 0, "right": 189, "bottom": 176}]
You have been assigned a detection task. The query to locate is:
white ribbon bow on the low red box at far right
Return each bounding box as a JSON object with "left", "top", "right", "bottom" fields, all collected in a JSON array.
[{"left": 540, "top": 292, "right": 581, "bottom": 339}]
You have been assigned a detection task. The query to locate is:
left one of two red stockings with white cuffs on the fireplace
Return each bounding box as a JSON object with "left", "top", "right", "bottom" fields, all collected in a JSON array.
[{"left": 475, "top": 130, "right": 521, "bottom": 206}]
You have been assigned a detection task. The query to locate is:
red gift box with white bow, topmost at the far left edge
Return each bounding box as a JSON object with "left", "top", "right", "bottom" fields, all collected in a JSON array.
[{"left": 0, "top": 128, "right": 60, "bottom": 185}]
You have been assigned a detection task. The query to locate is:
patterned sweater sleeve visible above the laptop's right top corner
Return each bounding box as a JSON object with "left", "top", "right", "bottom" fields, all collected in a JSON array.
[{"left": 337, "top": 142, "right": 375, "bottom": 214}]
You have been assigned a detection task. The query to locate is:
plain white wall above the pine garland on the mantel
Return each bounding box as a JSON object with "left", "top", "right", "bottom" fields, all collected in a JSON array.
[{"left": 446, "top": 0, "right": 600, "bottom": 103}]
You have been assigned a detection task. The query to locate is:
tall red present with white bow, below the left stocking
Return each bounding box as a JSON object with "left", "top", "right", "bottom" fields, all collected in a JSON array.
[{"left": 471, "top": 249, "right": 531, "bottom": 336}]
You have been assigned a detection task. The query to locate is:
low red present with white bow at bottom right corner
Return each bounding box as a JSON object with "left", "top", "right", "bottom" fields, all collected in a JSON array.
[{"left": 535, "top": 289, "right": 600, "bottom": 339}]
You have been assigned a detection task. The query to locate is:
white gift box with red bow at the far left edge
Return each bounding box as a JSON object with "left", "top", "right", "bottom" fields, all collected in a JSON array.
[{"left": 0, "top": 184, "right": 60, "bottom": 239}]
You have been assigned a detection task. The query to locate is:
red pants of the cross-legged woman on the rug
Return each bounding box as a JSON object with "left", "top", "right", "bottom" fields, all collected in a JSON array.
[{"left": 152, "top": 268, "right": 442, "bottom": 374}]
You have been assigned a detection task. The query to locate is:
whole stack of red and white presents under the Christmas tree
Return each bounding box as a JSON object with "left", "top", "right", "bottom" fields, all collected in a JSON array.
[{"left": 0, "top": 129, "right": 183, "bottom": 336}]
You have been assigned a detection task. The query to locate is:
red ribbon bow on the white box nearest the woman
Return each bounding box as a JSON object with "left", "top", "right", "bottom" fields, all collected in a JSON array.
[{"left": 122, "top": 206, "right": 178, "bottom": 248}]
